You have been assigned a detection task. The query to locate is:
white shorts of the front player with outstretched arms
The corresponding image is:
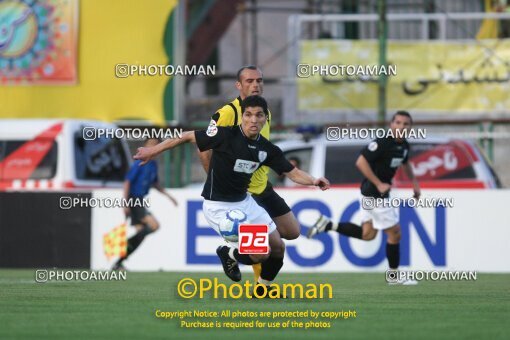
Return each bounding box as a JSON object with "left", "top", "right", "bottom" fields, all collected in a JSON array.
[{"left": 202, "top": 195, "right": 276, "bottom": 248}]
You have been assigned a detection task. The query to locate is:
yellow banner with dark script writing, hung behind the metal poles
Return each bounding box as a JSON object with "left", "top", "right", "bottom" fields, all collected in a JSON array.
[{"left": 297, "top": 40, "right": 510, "bottom": 113}]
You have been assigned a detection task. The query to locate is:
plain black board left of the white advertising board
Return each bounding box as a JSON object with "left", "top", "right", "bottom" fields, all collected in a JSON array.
[{"left": 0, "top": 192, "right": 91, "bottom": 268}]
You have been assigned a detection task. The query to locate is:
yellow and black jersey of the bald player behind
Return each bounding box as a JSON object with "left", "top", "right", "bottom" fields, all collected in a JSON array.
[{"left": 212, "top": 97, "right": 271, "bottom": 194}]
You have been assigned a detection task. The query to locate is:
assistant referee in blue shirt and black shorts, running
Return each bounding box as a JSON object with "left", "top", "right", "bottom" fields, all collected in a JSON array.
[{"left": 112, "top": 139, "right": 177, "bottom": 270}]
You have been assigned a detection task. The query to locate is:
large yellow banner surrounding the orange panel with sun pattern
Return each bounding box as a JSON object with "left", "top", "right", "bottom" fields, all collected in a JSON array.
[{"left": 0, "top": 0, "right": 178, "bottom": 124}]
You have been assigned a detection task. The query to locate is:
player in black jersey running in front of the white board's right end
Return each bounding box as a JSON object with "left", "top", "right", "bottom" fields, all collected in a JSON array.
[{"left": 307, "top": 111, "right": 420, "bottom": 284}]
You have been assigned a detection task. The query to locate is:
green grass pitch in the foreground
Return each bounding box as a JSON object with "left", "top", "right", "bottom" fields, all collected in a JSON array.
[{"left": 0, "top": 269, "right": 510, "bottom": 340}]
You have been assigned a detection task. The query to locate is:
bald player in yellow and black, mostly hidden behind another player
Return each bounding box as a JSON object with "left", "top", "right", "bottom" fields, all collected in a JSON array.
[{"left": 200, "top": 66, "right": 301, "bottom": 280}]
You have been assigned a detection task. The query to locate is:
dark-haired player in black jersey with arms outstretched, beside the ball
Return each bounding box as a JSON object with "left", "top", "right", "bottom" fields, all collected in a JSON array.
[{"left": 134, "top": 96, "right": 329, "bottom": 296}]
